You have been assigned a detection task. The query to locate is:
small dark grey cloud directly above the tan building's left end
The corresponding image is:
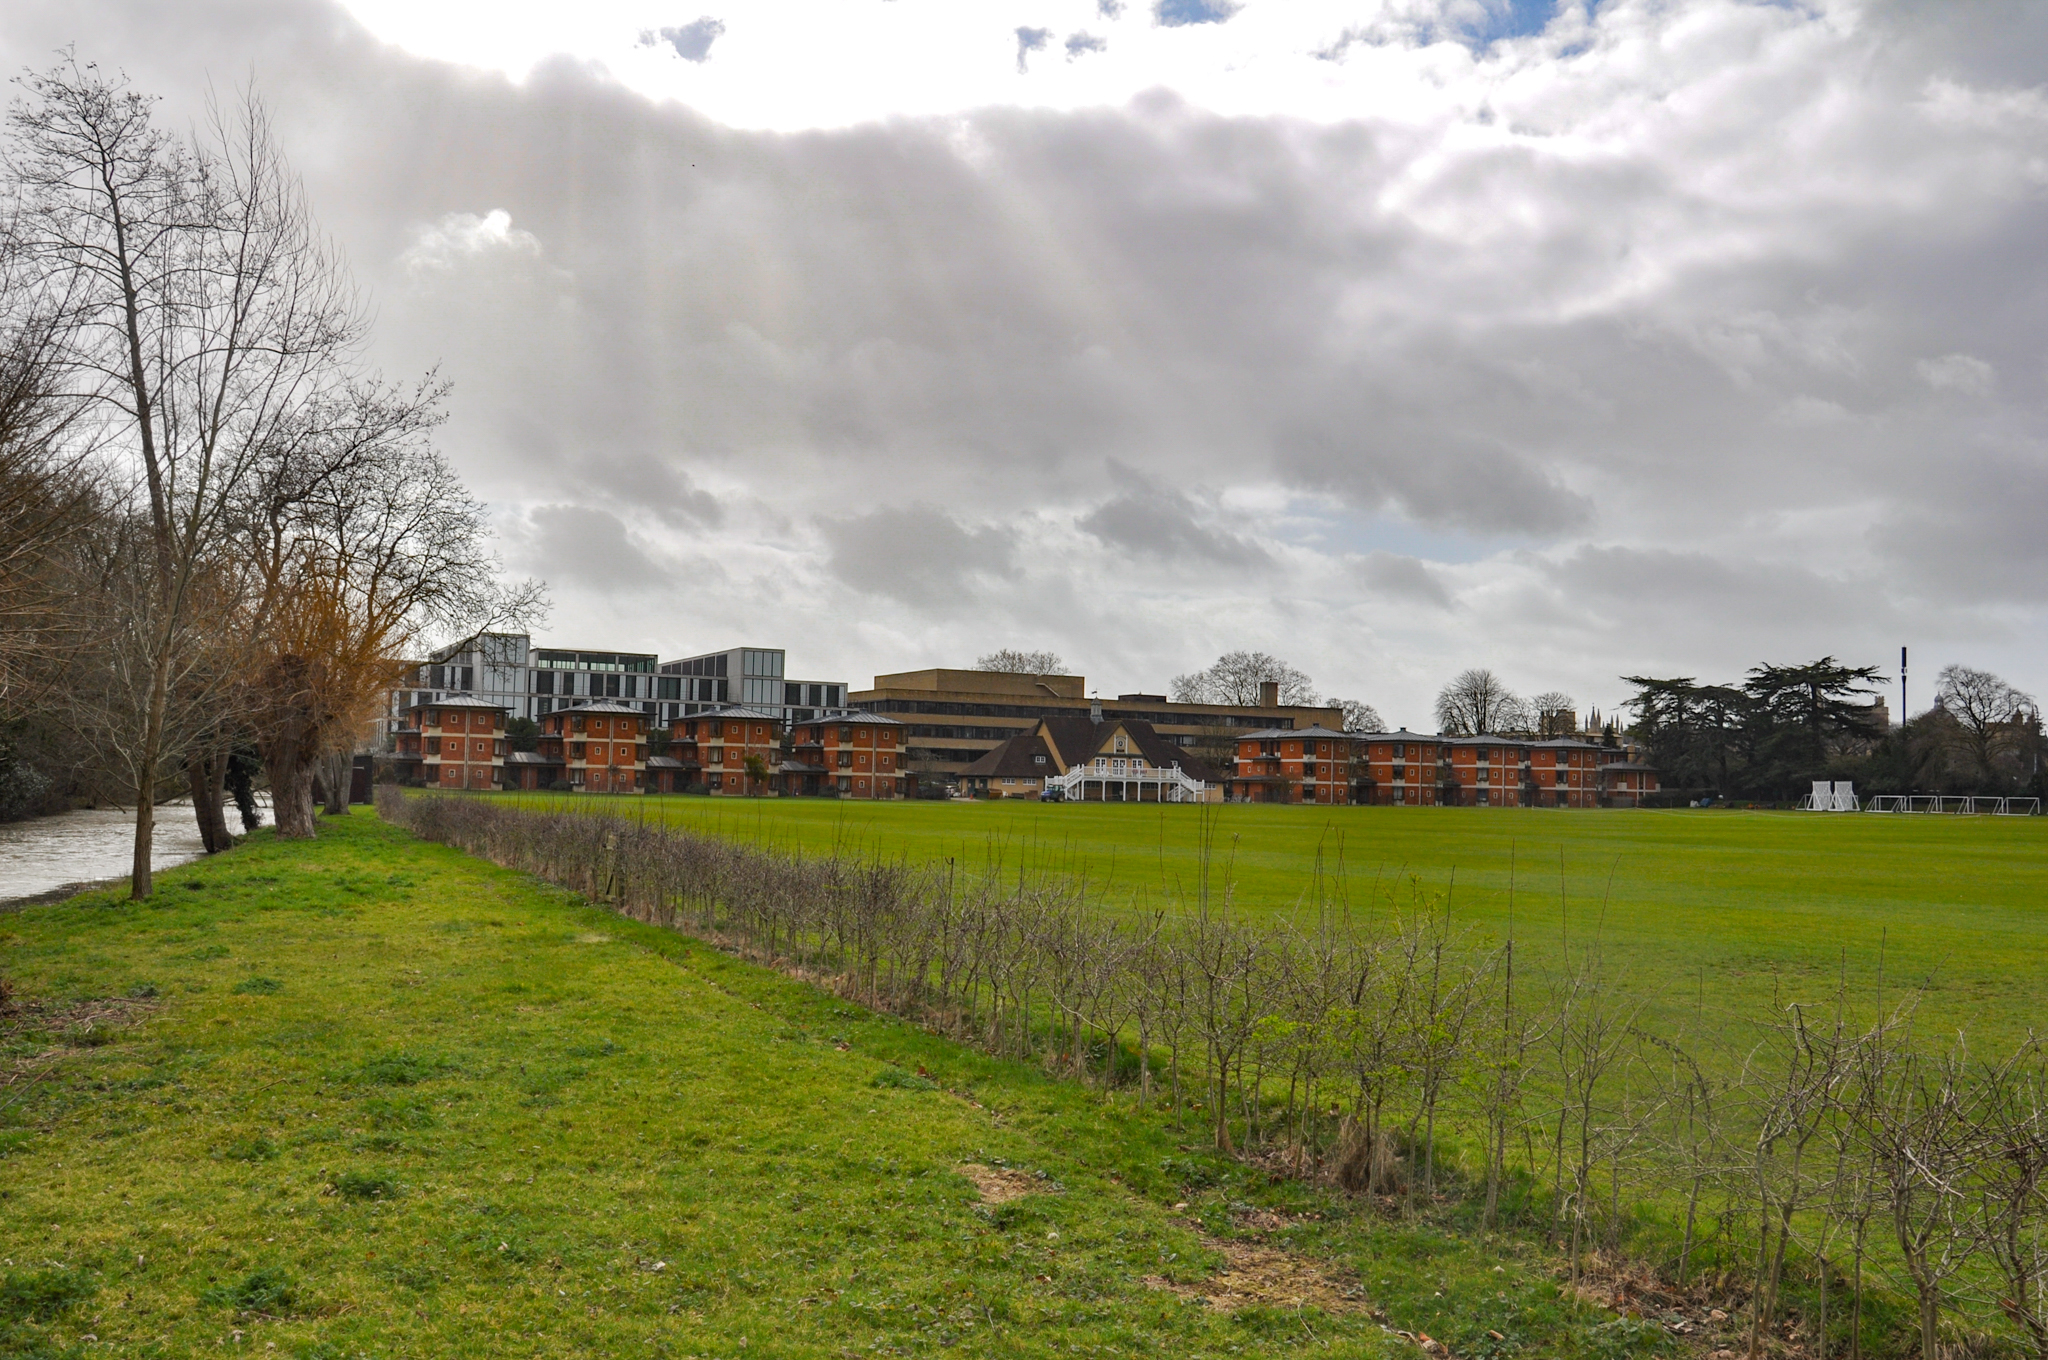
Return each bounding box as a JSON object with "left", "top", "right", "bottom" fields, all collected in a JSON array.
[{"left": 819, "top": 506, "right": 1018, "bottom": 612}]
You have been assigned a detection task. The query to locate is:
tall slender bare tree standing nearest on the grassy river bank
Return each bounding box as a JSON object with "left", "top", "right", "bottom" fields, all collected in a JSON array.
[{"left": 10, "top": 57, "right": 362, "bottom": 897}]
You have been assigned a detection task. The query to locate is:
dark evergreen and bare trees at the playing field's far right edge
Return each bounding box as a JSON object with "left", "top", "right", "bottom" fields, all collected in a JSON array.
[{"left": 1626, "top": 657, "right": 2042, "bottom": 799}]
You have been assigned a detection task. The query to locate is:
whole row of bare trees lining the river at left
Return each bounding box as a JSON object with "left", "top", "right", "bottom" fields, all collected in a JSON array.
[{"left": 0, "top": 59, "right": 541, "bottom": 897}]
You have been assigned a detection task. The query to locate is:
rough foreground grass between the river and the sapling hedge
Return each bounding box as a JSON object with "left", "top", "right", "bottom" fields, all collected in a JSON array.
[{"left": 0, "top": 807, "right": 1657, "bottom": 1360}]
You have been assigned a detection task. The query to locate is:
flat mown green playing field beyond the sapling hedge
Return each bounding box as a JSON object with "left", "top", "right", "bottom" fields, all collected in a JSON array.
[{"left": 494, "top": 795, "right": 2048, "bottom": 1038}]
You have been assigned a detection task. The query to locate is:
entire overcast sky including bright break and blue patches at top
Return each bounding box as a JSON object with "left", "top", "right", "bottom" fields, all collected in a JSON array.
[{"left": 0, "top": 0, "right": 2048, "bottom": 727}]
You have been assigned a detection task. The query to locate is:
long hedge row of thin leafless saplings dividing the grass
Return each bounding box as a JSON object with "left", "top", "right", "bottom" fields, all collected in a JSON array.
[{"left": 381, "top": 791, "right": 2048, "bottom": 1360}]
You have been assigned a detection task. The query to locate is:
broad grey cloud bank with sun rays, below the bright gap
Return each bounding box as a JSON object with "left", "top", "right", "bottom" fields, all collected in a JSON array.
[{"left": 24, "top": 0, "right": 2048, "bottom": 713}]
